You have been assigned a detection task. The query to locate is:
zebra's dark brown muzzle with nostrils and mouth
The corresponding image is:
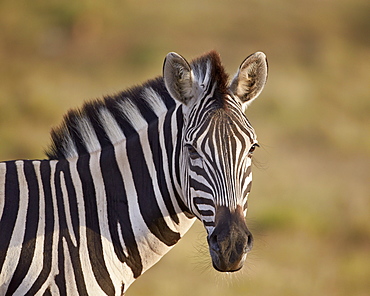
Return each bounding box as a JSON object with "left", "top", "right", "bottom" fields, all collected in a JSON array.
[{"left": 207, "top": 207, "right": 253, "bottom": 272}]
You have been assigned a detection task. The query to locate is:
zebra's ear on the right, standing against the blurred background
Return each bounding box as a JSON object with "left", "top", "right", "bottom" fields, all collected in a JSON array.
[{"left": 230, "top": 52, "right": 267, "bottom": 109}]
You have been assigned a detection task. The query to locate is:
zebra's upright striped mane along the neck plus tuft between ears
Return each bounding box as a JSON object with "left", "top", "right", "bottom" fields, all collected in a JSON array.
[{"left": 45, "top": 51, "right": 228, "bottom": 159}]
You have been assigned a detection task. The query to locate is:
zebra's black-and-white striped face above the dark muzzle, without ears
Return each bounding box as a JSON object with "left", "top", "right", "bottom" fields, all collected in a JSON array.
[{"left": 183, "top": 95, "right": 258, "bottom": 233}]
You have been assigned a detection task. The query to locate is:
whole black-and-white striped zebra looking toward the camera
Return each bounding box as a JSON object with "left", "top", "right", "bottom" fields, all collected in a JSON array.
[{"left": 0, "top": 51, "right": 267, "bottom": 295}]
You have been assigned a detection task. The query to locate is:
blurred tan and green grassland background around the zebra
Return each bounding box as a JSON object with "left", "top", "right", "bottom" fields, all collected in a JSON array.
[{"left": 0, "top": 0, "right": 370, "bottom": 296}]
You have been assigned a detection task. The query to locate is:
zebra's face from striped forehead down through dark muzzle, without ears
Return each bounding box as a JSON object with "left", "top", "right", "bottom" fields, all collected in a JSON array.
[{"left": 183, "top": 95, "right": 258, "bottom": 271}]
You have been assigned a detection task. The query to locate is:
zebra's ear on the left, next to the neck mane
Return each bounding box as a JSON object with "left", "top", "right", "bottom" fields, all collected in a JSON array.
[{"left": 163, "top": 52, "right": 193, "bottom": 105}]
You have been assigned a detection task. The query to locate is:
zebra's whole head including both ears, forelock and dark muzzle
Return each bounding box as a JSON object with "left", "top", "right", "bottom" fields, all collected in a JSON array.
[{"left": 163, "top": 52, "right": 267, "bottom": 272}]
